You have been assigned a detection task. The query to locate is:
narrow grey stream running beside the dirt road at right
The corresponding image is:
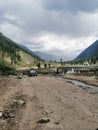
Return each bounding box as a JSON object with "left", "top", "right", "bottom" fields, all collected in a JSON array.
[{"left": 66, "top": 79, "right": 98, "bottom": 94}]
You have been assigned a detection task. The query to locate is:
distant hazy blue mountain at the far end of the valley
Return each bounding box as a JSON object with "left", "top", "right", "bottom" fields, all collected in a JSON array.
[{"left": 34, "top": 51, "right": 60, "bottom": 61}]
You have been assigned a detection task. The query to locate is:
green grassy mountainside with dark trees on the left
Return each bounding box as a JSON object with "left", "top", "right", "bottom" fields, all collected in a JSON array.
[{"left": 0, "top": 33, "right": 41, "bottom": 70}]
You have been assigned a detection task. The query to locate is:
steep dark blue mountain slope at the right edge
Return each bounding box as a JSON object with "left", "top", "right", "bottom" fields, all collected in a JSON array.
[{"left": 76, "top": 40, "right": 98, "bottom": 60}]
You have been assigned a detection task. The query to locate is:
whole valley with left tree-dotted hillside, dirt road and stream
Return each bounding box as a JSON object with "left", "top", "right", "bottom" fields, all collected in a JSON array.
[{"left": 0, "top": 35, "right": 98, "bottom": 130}]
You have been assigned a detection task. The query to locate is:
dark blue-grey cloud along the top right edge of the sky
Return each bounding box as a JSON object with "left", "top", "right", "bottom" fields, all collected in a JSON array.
[{"left": 43, "top": 0, "right": 98, "bottom": 12}]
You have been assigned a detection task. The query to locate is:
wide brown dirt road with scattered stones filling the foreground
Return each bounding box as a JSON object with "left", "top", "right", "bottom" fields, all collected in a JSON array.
[{"left": 0, "top": 76, "right": 98, "bottom": 130}]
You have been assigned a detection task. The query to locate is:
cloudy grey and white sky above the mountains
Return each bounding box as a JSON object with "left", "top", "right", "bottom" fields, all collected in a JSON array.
[{"left": 0, "top": 0, "right": 98, "bottom": 60}]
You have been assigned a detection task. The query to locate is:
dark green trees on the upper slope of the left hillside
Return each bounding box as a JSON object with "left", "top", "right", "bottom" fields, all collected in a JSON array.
[{"left": 0, "top": 34, "right": 21, "bottom": 64}]
